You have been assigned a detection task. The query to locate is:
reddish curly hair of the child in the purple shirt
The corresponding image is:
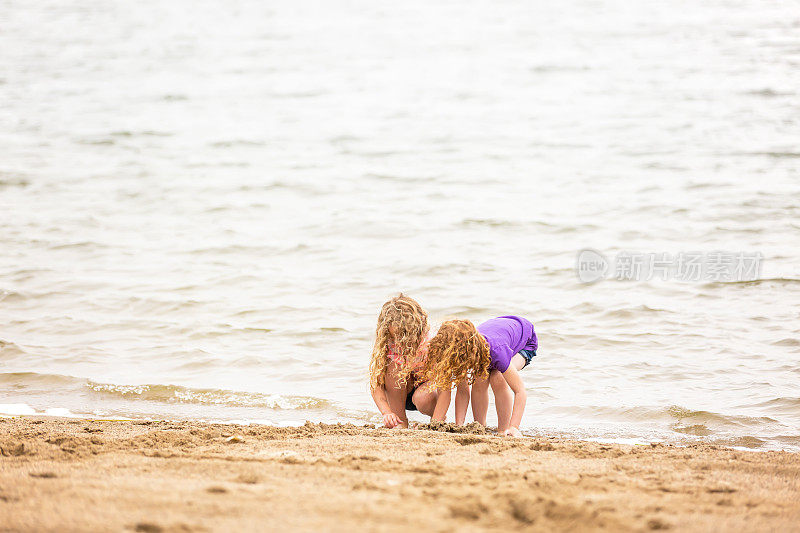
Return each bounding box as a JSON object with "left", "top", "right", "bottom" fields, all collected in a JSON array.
[{"left": 425, "top": 319, "right": 492, "bottom": 390}]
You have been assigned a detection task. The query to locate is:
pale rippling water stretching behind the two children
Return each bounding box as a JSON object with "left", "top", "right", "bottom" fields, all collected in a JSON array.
[{"left": 0, "top": 0, "right": 800, "bottom": 451}]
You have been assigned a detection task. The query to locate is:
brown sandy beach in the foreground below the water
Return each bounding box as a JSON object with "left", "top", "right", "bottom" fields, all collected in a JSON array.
[{"left": 0, "top": 417, "right": 800, "bottom": 533}]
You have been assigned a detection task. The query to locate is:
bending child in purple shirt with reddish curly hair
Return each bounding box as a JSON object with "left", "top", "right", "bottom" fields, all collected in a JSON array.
[{"left": 426, "top": 316, "right": 539, "bottom": 437}]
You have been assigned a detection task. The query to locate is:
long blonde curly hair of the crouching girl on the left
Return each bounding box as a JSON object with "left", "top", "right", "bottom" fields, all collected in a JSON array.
[{"left": 369, "top": 292, "right": 428, "bottom": 390}]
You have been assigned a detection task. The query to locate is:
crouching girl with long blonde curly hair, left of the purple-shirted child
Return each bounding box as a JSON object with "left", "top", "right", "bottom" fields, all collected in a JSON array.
[{"left": 369, "top": 293, "right": 450, "bottom": 428}]
